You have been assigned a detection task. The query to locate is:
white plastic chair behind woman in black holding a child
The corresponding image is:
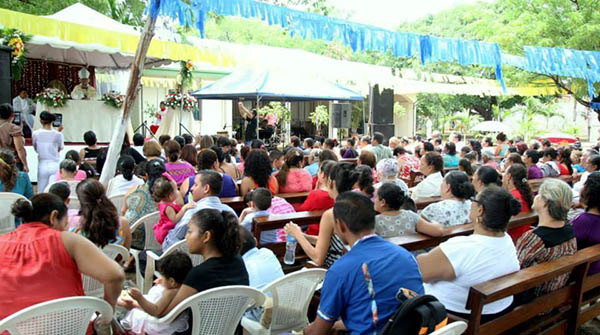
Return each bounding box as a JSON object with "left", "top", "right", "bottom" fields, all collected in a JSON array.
[{"left": 151, "top": 286, "right": 265, "bottom": 335}]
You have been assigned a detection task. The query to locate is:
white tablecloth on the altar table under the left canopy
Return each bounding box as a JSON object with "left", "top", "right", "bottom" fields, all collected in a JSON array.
[{"left": 33, "top": 100, "right": 133, "bottom": 143}]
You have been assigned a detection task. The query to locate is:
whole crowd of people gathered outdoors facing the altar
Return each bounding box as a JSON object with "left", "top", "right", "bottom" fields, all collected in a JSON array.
[{"left": 0, "top": 105, "right": 600, "bottom": 334}]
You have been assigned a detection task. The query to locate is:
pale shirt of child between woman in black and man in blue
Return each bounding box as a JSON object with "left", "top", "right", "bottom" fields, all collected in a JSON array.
[{"left": 242, "top": 248, "right": 283, "bottom": 290}]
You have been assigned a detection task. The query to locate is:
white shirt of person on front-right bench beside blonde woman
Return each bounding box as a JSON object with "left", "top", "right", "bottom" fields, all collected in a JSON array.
[{"left": 423, "top": 234, "right": 520, "bottom": 314}]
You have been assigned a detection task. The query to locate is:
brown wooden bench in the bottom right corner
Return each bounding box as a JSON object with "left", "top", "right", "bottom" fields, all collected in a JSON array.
[{"left": 458, "top": 245, "right": 600, "bottom": 335}]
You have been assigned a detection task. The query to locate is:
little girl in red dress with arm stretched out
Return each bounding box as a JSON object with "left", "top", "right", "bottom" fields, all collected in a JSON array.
[{"left": 152, "top": 177, "right": 196, "bottom": 244}]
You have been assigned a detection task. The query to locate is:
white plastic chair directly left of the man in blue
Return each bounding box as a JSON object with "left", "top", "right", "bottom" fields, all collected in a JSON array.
[{"left": 242, "top": 269, "right": 327, "bottom": 335}]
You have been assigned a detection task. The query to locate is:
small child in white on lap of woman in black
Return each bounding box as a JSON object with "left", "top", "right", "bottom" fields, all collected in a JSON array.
[{"left": 117, "top": 251, "right": 192, "bottom": 335}]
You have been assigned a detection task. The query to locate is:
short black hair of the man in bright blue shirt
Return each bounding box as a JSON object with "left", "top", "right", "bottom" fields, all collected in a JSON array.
[{"left": 333, "top": 192, "right": 376, "bottom": 234}]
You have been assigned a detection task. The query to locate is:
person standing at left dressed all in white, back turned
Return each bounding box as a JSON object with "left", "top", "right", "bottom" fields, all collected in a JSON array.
[{"left": 32, "top": 111, "right": 65, "bottom": 192}]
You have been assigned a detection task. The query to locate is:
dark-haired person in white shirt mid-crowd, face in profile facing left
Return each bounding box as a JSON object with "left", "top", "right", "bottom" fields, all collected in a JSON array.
[{"left": 410, "top": 152, "right": 444, "bottom": 199}]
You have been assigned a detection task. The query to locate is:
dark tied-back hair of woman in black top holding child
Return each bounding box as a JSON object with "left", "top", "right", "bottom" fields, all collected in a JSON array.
[{"left": 191, "top": 210, "right": 242, "bottom": 257}]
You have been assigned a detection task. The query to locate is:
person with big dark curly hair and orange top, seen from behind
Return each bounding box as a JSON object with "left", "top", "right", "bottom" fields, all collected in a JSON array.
[{"left": 240, "top": 149, "right": 279, "bottom": 197}]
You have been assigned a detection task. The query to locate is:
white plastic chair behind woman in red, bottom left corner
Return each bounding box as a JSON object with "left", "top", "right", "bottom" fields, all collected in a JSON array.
[{"left": 0, "top": 297, "right": 112, "bottom": 335}]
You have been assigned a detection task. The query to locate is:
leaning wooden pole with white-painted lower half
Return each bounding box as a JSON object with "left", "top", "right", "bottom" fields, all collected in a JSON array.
[{"left": 100, "top": 9, "right": 159, "bottom": 186}]
